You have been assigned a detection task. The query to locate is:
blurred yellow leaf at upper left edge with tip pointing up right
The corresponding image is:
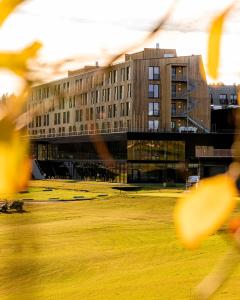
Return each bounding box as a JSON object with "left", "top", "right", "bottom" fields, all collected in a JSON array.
[{"left": 0, "top": 42, "right": 42, "bottom": 77}]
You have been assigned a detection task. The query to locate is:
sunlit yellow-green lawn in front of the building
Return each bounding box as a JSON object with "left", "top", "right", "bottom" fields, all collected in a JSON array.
[{"left": 0, "top": 181, "right": 240, "bottom": 300}]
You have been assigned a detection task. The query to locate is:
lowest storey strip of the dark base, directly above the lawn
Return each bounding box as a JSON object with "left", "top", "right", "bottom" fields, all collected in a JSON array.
[{"left": 38, "top": 160, "right": 231, "bottom": 186}]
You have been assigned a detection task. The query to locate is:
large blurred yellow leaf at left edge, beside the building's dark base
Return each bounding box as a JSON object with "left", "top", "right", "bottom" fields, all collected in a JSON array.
[{"left": 0, "top": 118, "right": 30, "bottom": 199}]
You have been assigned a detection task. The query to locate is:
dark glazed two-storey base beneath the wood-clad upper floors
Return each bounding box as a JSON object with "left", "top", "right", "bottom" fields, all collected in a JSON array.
[{"left": 32, "top": 132, "right": 232, "bottom": 185}]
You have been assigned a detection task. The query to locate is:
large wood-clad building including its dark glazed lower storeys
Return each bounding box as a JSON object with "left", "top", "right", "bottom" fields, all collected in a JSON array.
[{"left": 28, "top": 48, "right": 219, "bottom": 182}]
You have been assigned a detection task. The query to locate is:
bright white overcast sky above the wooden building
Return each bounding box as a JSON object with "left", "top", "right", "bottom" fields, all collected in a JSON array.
[{"left": 0, "top": 0, "right": 240, "bottom": 95}]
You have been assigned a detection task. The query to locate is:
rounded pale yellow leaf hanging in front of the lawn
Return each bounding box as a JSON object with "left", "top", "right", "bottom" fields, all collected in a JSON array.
[{"left": 174, "top": 173, "right": 238, "bottom": 248}]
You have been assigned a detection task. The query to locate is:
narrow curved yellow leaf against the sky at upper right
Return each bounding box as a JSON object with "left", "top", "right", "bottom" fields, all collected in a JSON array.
[{"left": 207, "top": 4, "right": 234, "bottom": 79}]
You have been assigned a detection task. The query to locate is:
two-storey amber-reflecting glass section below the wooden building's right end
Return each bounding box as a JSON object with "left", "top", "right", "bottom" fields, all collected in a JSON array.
[{"left": 127, "top": 140, "right": 186, "bottom": 184}]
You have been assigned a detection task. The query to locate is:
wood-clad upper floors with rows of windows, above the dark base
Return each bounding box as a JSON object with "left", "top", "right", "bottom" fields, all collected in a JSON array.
[{"left": 28, "top": 49, "right": 210, "bottom": 137}]
